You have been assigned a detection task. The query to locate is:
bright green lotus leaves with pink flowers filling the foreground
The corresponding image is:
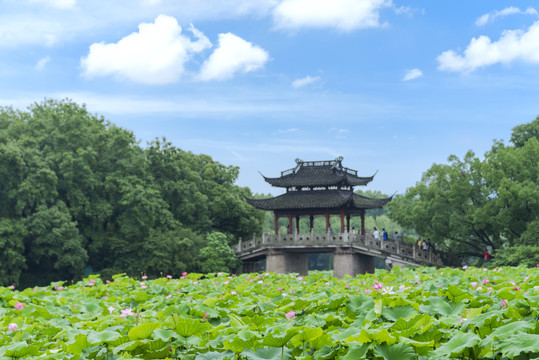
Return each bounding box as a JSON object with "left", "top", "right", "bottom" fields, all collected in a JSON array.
[{"left": 0, "top": 267, "right": 539, "bottom": 360}]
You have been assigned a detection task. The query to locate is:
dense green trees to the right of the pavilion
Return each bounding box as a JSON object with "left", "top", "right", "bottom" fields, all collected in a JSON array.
[{"left": 388, "top": 117, "right": 539, "bottom": 264}]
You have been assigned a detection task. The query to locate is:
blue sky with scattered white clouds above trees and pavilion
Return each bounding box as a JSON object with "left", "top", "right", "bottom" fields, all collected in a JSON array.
[{"left": 0, "top": 0, "right": 539, "bottom": 195}]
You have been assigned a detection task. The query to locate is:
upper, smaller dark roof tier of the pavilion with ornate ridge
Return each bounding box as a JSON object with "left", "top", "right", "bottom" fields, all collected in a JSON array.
[{"left": 262, "top": 157, "right": 374, "bottom": 188}]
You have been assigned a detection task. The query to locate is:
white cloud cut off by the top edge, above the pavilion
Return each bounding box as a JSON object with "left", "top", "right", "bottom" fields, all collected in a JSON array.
[{"left": 273, "top": 0, "right": 392, "bottom": 31}]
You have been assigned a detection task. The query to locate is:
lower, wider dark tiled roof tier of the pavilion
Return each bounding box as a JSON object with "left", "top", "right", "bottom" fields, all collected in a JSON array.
[{"left": 246, "top": 190, "right": 391, "bottom": 211}]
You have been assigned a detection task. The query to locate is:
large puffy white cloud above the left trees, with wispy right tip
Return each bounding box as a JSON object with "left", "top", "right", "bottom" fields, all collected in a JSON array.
[{"left": 81, "top": 15, "right": 211, "bottom": 84}]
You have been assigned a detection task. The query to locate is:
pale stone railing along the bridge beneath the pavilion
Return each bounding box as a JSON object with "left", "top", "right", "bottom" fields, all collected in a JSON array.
[{"left": 232, "top": 232, "right": 442, "bottom": 264}]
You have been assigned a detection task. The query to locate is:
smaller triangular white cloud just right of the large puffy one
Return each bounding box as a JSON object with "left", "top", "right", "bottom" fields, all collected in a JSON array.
[{"left": 199, "top": 33, "right": 269, "bottom": 81}]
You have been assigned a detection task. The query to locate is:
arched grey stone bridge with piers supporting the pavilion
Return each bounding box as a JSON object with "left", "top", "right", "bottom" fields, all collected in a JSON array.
[{"left": 232, "top": 232, "right": 442, "bottom": 278}]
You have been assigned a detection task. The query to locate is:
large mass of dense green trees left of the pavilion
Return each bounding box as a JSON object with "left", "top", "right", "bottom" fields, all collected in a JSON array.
[{"left": 0, "top": 100, "right": 264, "bottom": 285}]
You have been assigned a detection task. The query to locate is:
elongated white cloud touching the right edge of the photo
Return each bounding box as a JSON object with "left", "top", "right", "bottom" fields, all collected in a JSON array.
[{"left": 437, "top": 21, "right": 539, "bottom": 73}]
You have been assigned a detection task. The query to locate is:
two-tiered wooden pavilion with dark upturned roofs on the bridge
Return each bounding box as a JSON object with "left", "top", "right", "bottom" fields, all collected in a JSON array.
[{"left": 247, "top": 156, "right": 392, "bottom": 235}]
